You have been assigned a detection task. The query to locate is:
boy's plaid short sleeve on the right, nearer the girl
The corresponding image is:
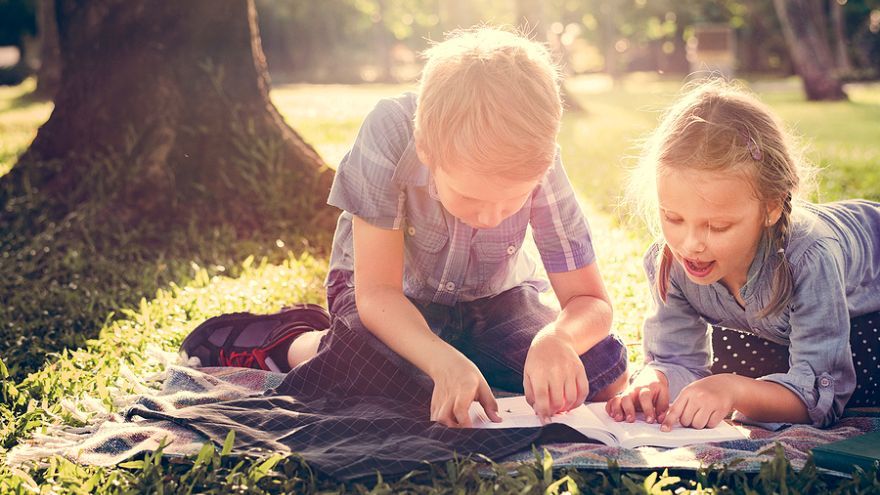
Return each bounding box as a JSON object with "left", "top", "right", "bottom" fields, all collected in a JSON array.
[{"left": 529, "top": 149, "right": 596, "bottom": 273}]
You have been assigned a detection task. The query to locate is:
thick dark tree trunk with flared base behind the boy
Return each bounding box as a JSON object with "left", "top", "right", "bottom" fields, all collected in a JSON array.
[{"left": 0, "top": 0, "right": 336, "bottom": 236}]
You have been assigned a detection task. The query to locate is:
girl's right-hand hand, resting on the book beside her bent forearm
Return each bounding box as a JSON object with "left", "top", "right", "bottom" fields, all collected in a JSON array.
[{"left": 660, "top": 374, "right": 738, "bottom": 431}]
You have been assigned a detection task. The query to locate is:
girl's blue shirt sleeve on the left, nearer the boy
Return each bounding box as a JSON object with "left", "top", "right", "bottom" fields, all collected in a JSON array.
[{"left": 643, "top": 244, "right": 712, "bottom": 401}]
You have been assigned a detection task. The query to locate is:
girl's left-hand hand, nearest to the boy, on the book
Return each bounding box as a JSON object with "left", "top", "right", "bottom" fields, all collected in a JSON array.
[{"left": 605, "top": 369, "right": 669, "bottom": 423}]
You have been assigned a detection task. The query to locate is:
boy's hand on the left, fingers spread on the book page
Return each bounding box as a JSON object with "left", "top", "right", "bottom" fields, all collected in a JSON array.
[{"left": 431, "top": 348, "right": 501, "bottom": 428}]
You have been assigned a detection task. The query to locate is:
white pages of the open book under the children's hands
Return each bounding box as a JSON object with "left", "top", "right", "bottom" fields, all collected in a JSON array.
[{"left": 470, "top": 395, "right": 748, "bottom": 448}]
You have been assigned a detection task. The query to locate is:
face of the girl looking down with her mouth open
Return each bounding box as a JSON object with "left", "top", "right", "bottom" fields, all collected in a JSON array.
[{"left": 657, "top": 168, "right": 781, "bottom": 295}]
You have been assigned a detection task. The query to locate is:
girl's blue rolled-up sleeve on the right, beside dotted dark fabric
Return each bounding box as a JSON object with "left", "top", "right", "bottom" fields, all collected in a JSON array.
[{"left": 760, "top": 239, "right": 856, "bottom": 427}]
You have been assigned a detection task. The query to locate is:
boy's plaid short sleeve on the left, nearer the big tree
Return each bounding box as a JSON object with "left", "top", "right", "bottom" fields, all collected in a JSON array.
[{"left": 327, "top": 99, "right": 411, "bottom": 230}]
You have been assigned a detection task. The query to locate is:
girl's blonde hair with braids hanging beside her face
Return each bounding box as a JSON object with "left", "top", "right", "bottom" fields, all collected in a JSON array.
[{"left": 628, "top": 79, "right": 812, "bottom": 316}]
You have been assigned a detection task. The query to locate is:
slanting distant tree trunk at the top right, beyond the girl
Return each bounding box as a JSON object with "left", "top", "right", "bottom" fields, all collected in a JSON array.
[{"left": 773, "top": 0, "right": 846, "bottom": 100}]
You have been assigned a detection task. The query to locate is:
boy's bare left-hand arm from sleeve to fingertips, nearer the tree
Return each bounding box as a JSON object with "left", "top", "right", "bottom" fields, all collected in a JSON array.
[{"left": 352, "top": 216, "right": 500, "bottom": 426}]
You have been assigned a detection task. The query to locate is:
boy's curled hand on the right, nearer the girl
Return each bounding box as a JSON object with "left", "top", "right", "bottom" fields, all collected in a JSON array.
[{"left": 523, "top": 333, "right": 590, "bottom": 423}]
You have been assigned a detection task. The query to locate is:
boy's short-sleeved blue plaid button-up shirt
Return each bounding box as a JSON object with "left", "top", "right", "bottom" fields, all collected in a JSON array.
[{"left": 328, "top": 93, "right": 595, "bottom": 305}]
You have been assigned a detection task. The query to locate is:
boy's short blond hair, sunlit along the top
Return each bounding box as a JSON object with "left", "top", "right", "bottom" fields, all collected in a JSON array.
[{"left": 415, "top": 27, "right": 562, "bottom": 180}]
